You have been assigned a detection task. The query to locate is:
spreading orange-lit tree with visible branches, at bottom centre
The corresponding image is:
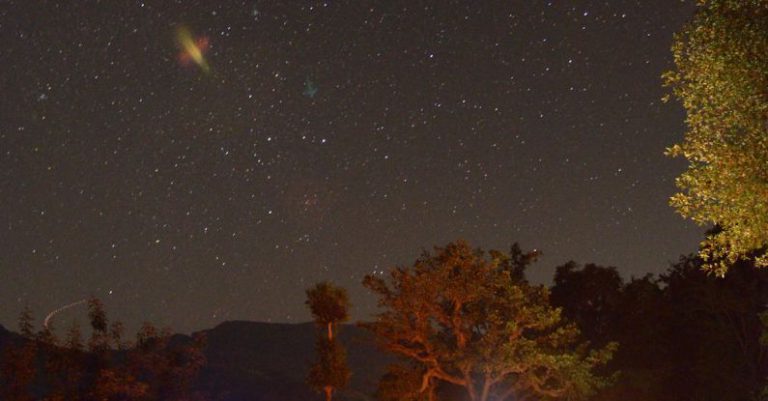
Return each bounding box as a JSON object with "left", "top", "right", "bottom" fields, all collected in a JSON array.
[{"left": 364, "top": 242, "right": 614, "bottom": 401}]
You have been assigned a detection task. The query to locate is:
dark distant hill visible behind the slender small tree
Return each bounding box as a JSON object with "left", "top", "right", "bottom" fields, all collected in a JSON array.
[{"left": 0, "top": 321, "right": 389, "bottom": 401}]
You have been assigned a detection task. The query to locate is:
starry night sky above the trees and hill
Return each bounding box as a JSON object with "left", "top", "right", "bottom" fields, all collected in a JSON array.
[{"left": 0, "top": 0, "right": 704, "bottom": 332}]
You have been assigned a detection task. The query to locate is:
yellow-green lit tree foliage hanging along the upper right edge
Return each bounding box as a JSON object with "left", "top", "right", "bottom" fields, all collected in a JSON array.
[{"left": 664, "top": 0, "right": 768, "bottom": 275}]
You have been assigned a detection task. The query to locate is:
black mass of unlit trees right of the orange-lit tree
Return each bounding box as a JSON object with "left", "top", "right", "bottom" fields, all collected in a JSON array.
[{"left": 552, "top": 256, "right": 768, "bottom": 401}]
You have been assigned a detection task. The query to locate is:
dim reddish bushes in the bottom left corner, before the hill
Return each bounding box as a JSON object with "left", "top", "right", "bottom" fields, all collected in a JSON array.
[{"left": 0, "top": 299, "right": 205, "bottom": 401}]
